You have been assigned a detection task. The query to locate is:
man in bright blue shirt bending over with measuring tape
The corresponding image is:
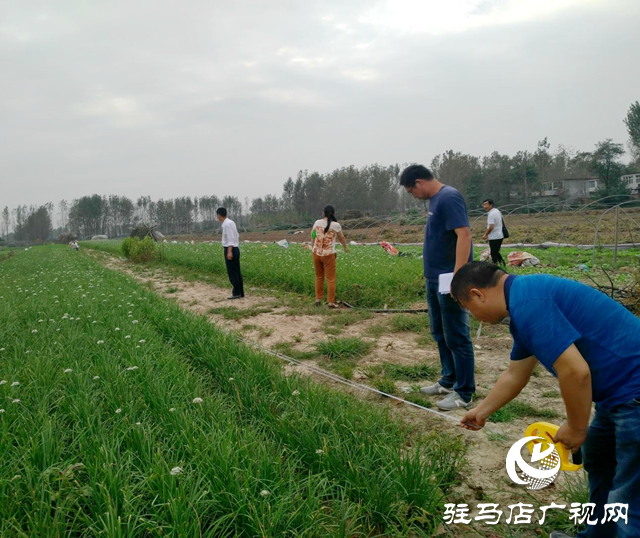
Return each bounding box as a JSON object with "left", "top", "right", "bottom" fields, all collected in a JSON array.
[{"left": 451, "top": 262, "right": 640, "bottom": 538}]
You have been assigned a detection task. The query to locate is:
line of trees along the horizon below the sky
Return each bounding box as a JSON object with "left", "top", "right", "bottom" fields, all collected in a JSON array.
[{"left": 0, "top": 101, "right": 640, "bottom": 241}]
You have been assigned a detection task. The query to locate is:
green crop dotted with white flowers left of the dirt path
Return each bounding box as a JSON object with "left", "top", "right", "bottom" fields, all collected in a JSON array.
[{"left": 0, "top": 247, "right": 463, "bottom": 537}]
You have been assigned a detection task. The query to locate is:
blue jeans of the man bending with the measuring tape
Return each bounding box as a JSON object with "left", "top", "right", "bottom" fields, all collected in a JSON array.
[{"left": 578, "top": 399, "right": 640, "bottom": 538}]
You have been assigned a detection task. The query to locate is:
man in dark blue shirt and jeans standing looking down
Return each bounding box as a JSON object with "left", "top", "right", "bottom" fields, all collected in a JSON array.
[{"left": 400, "top": 164, "right": 476, "bottom": 411}]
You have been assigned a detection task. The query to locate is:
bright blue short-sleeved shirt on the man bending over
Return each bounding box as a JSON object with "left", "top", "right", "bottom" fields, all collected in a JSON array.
[{"left": 505, "top": 275, "right": 640, "bottom": 409}]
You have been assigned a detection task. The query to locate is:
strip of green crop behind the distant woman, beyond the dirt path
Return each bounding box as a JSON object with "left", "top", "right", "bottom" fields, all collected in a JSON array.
[{"left": 81, "top": 241, "right": 638, "bottom": 308}]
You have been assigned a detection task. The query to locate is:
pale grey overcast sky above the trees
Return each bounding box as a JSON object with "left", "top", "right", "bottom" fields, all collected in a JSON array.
[{"left": 0, "top": 0, "right": 640, "bottom": 207}]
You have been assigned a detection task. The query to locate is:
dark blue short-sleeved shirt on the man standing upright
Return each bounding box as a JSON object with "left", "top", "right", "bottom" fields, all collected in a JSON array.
[{"left": 422, "top": 185, "right": 473, "bottom": 283}]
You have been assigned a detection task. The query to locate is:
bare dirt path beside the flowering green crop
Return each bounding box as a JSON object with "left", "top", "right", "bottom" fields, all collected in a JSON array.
[{"left": 89, "top": 251, "right": 580, "bottom": 528}]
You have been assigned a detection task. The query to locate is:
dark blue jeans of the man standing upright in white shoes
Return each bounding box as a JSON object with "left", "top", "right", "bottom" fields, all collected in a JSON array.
[{"left": 427, "top": 281, "right": 476, "bottom": 402}]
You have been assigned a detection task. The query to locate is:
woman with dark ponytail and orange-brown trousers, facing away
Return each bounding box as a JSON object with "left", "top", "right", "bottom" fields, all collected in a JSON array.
[{"left": 311, "top": 205, "right": 349, "bottom": 308}]
